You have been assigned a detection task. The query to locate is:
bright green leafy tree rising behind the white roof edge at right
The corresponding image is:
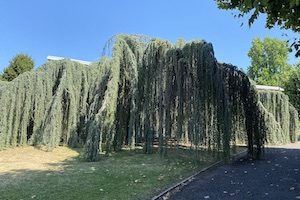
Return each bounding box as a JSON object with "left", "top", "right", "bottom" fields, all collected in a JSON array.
[{"left": 248, "top": 37, "right": 292, "bottom": 87}]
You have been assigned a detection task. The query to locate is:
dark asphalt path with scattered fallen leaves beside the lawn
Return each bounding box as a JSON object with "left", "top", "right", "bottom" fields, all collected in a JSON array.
[{"left": 169, "top": 143, "right": 300, "bottom": 200}]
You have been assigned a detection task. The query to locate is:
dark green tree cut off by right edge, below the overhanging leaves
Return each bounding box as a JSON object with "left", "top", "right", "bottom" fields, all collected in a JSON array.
[{"left": 284, "top": 62, "right": 300, "bottom": 115}]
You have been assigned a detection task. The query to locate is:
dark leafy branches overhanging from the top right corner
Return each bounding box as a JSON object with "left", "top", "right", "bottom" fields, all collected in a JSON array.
[{"left": 215, "top": 0, "right": 300, "bottom": 57}]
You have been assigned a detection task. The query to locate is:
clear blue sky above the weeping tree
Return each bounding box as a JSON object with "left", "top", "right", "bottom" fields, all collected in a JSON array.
[{"left": 0, "top": 0, "right": 299, "bottom": 72}]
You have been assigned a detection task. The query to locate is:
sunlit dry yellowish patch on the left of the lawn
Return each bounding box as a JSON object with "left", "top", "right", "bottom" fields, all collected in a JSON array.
[{"left": 0, "top": 146, "right": 79, "bottom": 186}]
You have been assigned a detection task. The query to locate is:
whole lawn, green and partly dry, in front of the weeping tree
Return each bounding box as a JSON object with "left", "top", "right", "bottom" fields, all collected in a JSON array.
[{"left": 0, "top": 147, "right": 214, "bottom": 200}]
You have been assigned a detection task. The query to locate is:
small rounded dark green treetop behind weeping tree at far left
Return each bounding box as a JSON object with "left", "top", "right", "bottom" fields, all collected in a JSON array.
[{"left": 2, "top": 53, "right": 34, "bottom": 81}]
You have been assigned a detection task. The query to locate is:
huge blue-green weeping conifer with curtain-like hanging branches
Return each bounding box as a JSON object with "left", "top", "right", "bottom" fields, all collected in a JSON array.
[{"left": 0, "top": 35, "right": 297, "bottom": 161}]
